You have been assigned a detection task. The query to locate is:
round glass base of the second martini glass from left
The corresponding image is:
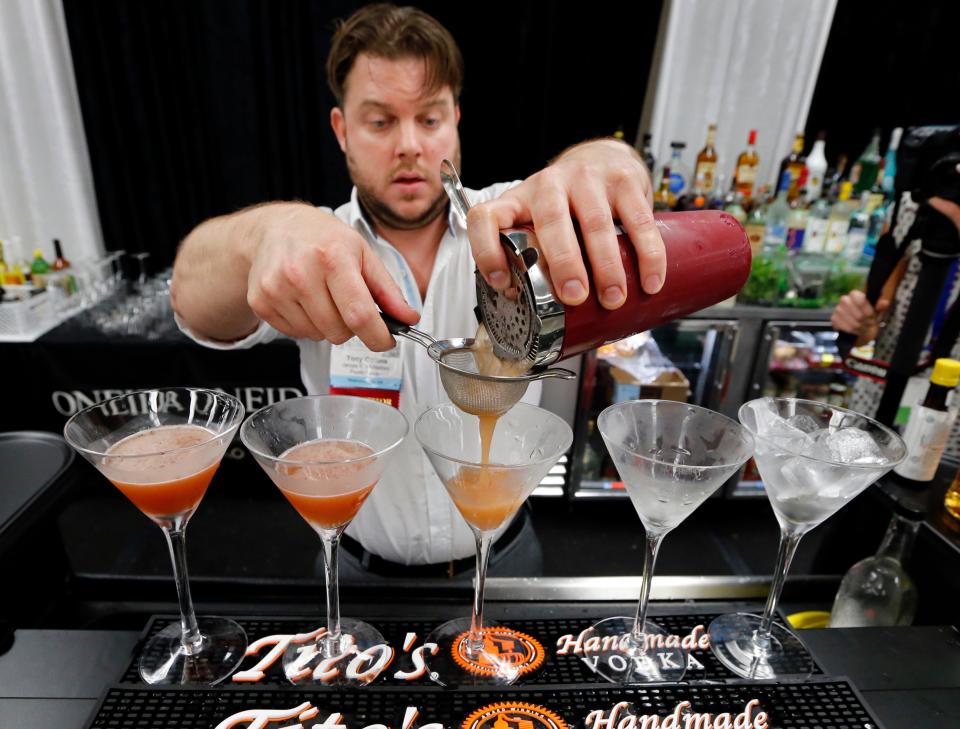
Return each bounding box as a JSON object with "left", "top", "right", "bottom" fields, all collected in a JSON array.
[{"left": 283, "top": 618, "right": 392, "bottom": 687}]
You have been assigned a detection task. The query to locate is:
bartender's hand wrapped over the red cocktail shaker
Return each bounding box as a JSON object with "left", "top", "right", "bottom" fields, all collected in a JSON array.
[{"left": 468, "top": 140, "right": 667, "bottom": 309}]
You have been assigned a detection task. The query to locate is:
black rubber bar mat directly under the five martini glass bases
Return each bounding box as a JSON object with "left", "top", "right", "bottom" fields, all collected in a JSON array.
[{"left": 120, "top": 614, "right": 823, "bottom": 687}]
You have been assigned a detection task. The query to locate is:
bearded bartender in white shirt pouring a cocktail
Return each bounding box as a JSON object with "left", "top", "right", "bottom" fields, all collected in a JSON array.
[{"left": 171, "top": 5, "right": 666, "bottom": 580}]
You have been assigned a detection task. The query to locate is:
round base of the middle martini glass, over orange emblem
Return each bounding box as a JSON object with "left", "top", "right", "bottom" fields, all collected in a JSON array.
[{"left": 424, "top": 618, "right": 545, "bottom": 688}]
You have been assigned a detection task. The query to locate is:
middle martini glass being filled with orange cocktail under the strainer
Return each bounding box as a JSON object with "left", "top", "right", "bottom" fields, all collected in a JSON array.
[{"left": 414, "top": 403, "right": 573, "bottom": 686}]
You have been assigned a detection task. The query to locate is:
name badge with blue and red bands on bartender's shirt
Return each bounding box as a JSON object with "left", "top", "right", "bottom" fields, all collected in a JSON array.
[{"left": 330, "top": 337, "right": 403, "bottom": 408}]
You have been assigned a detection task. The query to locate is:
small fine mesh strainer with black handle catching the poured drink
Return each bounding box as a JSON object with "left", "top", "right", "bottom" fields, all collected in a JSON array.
[{"left": 381, "top": 314, "right": 576, "bottom": 415}]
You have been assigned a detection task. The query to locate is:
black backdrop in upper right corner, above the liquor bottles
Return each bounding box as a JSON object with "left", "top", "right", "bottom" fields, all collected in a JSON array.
[{"left": 804, "top": 0, "right": 960, "bottom": 171}]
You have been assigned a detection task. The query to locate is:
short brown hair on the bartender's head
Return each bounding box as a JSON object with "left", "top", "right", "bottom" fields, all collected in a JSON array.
[{"left": 327, "top": 3, "right": 463, "bottom": 106}]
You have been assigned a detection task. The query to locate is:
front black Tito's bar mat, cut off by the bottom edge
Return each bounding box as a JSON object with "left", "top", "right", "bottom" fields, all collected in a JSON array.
[{"left": 87, "top": 678, "right": 881, "bottom": 729}]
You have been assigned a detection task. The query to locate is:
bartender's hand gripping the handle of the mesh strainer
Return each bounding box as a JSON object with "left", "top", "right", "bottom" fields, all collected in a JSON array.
[{"left": 247, "top": 204, "right": 419, "bottom": 352}]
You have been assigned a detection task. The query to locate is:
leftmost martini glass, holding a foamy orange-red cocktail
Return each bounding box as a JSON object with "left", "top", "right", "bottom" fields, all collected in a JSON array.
[{"left": 63, "top": 387, "right": 247, "bottom": 685}]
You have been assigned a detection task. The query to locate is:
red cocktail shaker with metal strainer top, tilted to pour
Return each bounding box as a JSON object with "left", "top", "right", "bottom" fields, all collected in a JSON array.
[{"left": 476, "top": 210, "right": 750, "bottom": 368}]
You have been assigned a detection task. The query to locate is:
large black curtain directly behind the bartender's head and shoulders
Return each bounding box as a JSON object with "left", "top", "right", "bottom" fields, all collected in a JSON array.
[{"left": 63, "top": 0, "right": 662, "bottom": 265}]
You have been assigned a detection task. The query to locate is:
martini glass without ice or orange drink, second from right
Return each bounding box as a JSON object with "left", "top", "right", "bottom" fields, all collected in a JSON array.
[{"left": 583, "top": 400, "right": 753, "bottom": 683}]
